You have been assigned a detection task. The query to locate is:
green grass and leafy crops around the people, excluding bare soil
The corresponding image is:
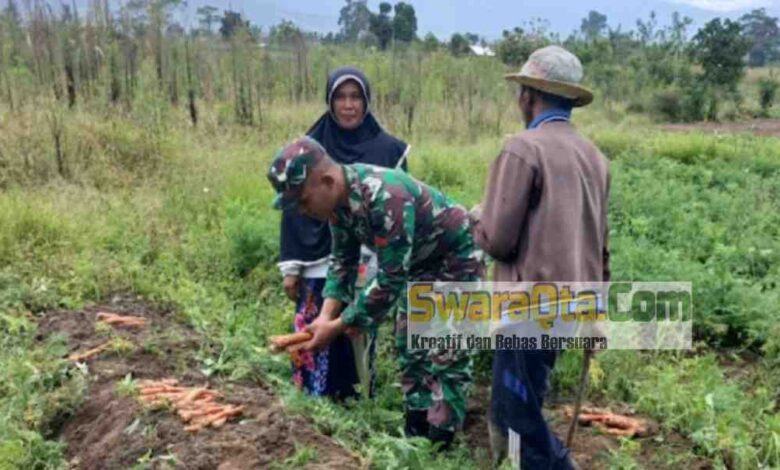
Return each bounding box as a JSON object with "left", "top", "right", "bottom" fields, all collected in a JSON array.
[{"left": 0, "top": 93, "right": 780, "bottom": 468}]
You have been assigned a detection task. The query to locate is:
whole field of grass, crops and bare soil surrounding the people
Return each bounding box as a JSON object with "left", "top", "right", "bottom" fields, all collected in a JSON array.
[{"left": 0, "top": 2, "right": 780, "bottom": 469}]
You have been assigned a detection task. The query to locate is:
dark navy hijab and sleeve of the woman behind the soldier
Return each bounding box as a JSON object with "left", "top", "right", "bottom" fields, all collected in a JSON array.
[{"left": 281, "top": 67, "right": 407, "bottom": 268}]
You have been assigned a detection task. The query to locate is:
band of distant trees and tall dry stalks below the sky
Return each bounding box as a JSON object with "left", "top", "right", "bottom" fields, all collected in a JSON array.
[{"left": 0, "top": 0, "right": 780, "bottom": 127}]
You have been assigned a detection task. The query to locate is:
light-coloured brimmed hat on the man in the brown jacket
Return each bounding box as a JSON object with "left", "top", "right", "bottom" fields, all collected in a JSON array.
[{"left": 504, "top": 46, "right": 593, "bottom": 106}]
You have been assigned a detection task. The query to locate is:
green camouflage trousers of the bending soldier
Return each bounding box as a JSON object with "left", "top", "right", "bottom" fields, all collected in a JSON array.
[{"left": 395, "top": 249, "right": 484, "bottom": 432}]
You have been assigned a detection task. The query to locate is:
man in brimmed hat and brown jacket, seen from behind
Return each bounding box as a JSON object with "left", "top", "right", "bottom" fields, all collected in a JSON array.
[{"left": 472, "top": 46, "right": 609, "bottom": 469}]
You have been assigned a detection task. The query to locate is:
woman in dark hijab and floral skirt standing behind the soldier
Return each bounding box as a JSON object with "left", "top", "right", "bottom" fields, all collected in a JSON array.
[{"left": 279, "top": 67, "right": 409, "bottom": 400}]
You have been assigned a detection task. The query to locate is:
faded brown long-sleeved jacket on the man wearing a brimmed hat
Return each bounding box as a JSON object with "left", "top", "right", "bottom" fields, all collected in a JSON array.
[{"left": 474, "top": 122, "right": 609, "bottom": 282}]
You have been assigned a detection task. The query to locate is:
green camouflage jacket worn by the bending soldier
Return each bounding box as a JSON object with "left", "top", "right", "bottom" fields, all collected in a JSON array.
[{"left": 324, "top": 164, "right": 482, "bottom": 327}]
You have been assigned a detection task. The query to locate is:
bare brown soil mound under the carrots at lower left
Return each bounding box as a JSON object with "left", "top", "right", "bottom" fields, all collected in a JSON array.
[{"left": 39, "top": 297, "right": 363, "bottom": 470}]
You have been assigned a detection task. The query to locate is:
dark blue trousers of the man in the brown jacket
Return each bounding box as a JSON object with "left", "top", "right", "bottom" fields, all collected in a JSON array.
[{"left": 490, "top": 351, "right": 574, "bottom": 470}]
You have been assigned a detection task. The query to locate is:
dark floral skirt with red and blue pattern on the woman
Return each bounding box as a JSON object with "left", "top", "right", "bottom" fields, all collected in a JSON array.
[{"left": 293, "top": 278, "right": 360, "bottom": 400}]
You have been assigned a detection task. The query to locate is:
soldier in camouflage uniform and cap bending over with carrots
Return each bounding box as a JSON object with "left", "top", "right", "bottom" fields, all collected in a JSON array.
[{"left": 268, "top": 138, "right": 484, "bottom": 446}]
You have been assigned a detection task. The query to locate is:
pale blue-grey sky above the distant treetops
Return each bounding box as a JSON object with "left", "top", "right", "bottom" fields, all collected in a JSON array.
[{"left": 68, "top": 0, "right": 780, "bottom": 39}]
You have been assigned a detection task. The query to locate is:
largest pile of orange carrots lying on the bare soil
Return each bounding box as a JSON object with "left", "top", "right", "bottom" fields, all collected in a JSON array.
[{"left": 139, "top": 379, "right": 244, "bottom": 432}]
